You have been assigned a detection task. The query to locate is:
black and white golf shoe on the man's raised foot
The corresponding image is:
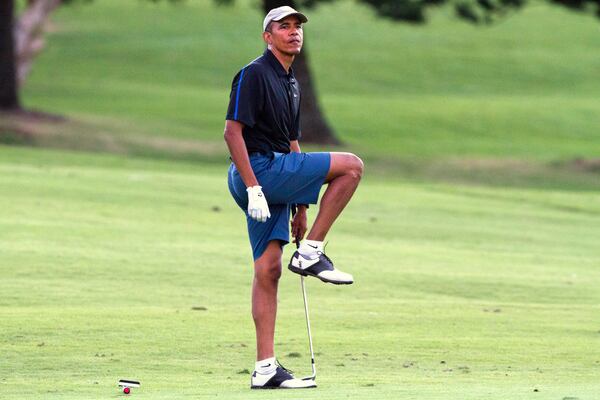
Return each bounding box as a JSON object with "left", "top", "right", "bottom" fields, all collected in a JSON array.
[{"left": 288, "top": 251, "right": 354, "bottom": 285}]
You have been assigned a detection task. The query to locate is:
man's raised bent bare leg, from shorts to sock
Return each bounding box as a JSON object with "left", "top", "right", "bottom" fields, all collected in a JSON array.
[{"left": 307, "top": 153, "right": 363, "bottom": 241}]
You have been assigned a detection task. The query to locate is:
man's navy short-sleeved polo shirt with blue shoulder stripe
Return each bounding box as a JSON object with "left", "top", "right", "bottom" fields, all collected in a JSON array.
[{"left": 226, "top": 50, "right": 300, "bottom": 154}]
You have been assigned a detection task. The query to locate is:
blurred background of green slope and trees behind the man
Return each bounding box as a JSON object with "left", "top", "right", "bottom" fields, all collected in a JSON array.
[{"left": 0, "top": 0, "right": 600, "bottom": 185}]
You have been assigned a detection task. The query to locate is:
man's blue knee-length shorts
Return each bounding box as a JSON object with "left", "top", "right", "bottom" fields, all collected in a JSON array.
[{"left": 228, "top": 153, "right": 331, "bottom": 260}]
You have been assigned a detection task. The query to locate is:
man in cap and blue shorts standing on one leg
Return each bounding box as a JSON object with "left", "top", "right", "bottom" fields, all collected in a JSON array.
[{"left": 225, "top": 6, "right": 363, "bottom": 389}]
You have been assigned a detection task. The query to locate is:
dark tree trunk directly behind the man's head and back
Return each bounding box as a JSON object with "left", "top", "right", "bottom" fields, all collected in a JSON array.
[{"left": 263, "top": 0, "right": 340, "bottom": 144}]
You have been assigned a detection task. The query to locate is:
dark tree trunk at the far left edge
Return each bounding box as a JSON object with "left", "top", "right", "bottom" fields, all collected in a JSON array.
[{"left": 0, "top": 0, "right": 21, "bottom": 110}]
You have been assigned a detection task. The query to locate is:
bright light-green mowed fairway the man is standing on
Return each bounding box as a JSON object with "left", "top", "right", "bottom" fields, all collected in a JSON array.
[{"left": 0, "top": 147, "right": 600, "bottom": 400}]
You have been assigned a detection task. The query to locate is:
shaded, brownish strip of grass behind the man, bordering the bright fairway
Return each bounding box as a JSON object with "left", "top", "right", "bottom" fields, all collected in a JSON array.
[{"left": 0, "top": 112, "right": 600, "bottom": 191}]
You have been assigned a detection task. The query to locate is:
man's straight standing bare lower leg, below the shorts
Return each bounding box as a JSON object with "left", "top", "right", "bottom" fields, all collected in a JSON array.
[{"left": 252, "top": 240, "right": 282, "bottom": 361}]
